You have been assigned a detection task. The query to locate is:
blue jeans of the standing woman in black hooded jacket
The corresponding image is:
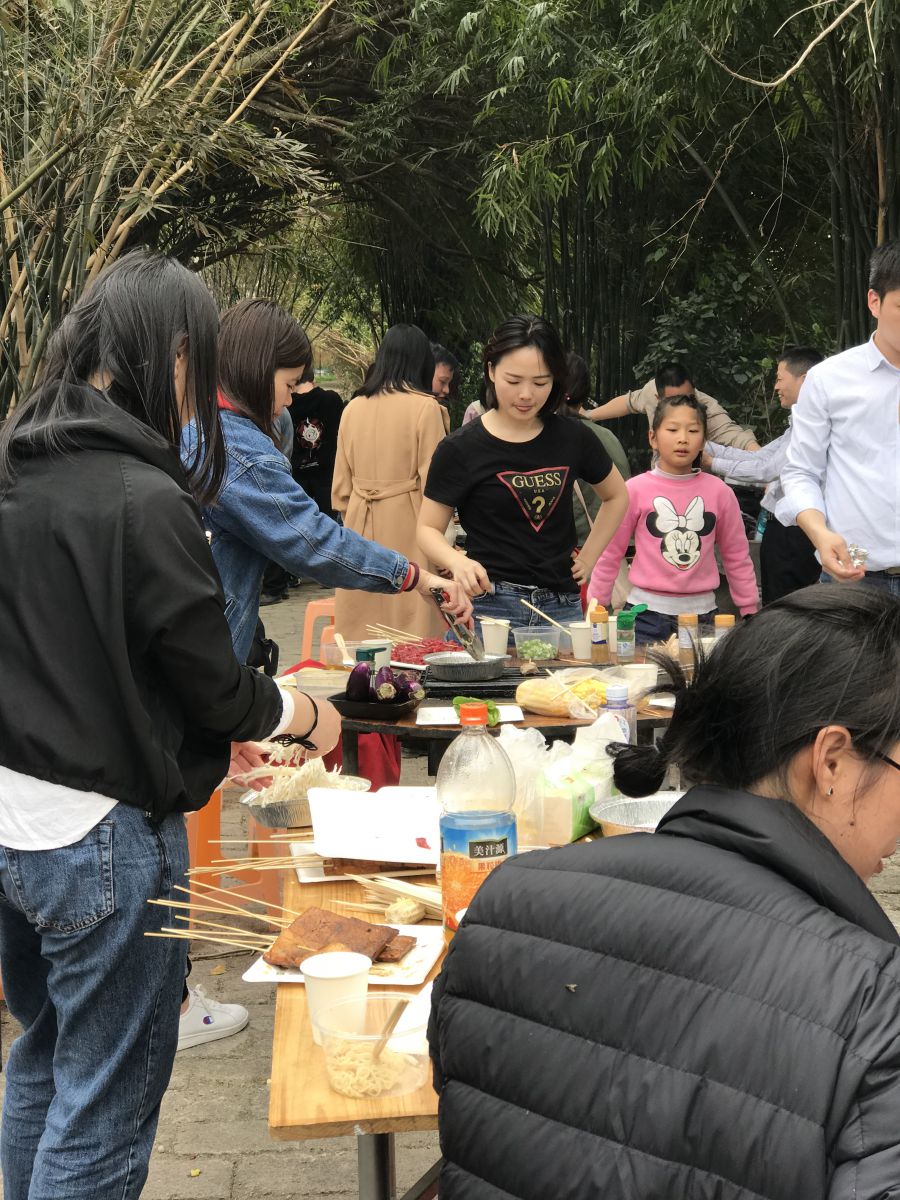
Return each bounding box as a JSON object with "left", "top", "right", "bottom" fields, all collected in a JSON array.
[{"left": 0, "top": 804, "right": 187, "bottom": 1200}]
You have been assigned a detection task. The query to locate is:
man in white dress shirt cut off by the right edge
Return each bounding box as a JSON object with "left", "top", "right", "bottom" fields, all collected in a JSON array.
[{"left": 775, "top": 241, "right": 900, "bottom": 596}]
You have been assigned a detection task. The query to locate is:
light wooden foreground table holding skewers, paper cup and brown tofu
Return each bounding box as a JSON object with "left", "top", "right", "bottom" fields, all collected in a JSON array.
[{"left": 269, "top": 878, "right": 443, "bottom": 1200}]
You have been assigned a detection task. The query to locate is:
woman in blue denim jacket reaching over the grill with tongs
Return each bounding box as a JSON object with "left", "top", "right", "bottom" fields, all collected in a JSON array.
[{"left": 182, "top": 300, "right": 472, "bottom": 661}]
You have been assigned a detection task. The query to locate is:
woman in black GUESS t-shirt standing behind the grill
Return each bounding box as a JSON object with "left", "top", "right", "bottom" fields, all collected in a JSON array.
[{"left": 418, "top": 317, "right": 628, "bottom": 625}]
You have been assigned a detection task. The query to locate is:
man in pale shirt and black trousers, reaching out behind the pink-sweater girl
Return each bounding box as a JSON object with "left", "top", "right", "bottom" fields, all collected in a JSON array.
[{"left": 703, "top": 346, "right": 823, "bottom": 604}]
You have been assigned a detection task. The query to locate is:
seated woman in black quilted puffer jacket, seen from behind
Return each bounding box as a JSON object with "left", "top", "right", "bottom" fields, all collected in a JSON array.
[{"left": 430, "top": 584, "right": 900, "bottom": 1200}]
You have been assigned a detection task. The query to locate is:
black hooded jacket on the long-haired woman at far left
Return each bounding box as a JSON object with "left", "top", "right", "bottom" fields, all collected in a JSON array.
[{"left": 0, "top": 395, "right": 281, "bottom": 820}]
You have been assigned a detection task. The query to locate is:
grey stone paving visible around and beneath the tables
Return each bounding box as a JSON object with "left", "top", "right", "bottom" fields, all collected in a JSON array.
[{"left": 0, "top": 578, "right": 900, "bottom": 1200}]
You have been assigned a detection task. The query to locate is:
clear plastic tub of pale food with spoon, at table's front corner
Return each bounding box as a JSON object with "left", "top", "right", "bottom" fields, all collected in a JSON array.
[{"left": 316, "top": 991, "right": 431, "bottom": 1099}]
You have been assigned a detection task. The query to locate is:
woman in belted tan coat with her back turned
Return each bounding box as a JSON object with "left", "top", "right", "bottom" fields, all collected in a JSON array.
[{"left": 331, "top": 325, "right": 445, "bottom": 638}]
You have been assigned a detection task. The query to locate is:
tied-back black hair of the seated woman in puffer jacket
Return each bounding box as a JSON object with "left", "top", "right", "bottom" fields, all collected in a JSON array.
[{"left": 610, "top": 583, "right": 900, "bottom": 796}]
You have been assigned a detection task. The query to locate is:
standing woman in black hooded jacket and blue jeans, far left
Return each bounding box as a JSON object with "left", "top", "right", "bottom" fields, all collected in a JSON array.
[{"left": 0, "top": 252, "right": 340, "bottom": 1200}]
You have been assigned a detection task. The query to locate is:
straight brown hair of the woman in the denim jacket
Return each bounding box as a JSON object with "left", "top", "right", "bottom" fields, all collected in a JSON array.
[{"left": 218, "top": 300, "right": 312, "bottom": 438}]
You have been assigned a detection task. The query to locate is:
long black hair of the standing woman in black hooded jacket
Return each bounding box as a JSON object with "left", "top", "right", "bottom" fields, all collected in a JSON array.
[{"left": 0, "top": 250, "right": 226, "bottom": 503}]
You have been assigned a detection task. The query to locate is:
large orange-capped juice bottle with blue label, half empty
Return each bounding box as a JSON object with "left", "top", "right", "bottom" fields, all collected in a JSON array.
[{"left": 436, "top": 703, "right": 516, "bottom": 935}]
